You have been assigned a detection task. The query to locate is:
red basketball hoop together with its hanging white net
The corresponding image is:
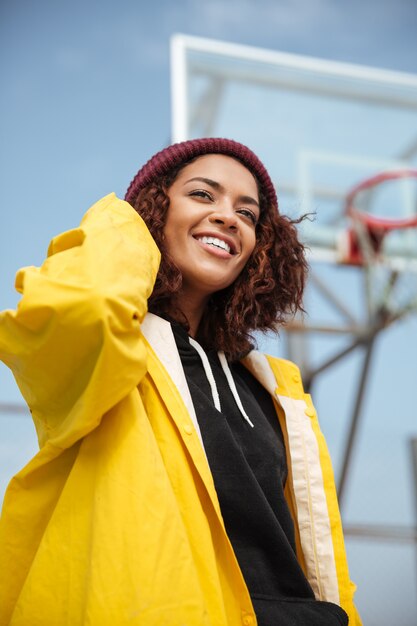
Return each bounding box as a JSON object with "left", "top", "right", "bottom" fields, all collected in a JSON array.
[{"left": 339, "top": 169, "right": 417, "bottom": 325}]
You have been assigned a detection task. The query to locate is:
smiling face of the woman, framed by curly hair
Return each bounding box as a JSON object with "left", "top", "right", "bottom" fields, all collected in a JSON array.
[{"left": 164, "top": 154, "right": 260, "bottom": 298}]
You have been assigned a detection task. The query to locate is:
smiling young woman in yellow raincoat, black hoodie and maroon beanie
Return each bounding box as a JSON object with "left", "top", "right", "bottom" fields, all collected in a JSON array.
[{"left": 0, "top": 139, "right": 360, "bottom": 626}]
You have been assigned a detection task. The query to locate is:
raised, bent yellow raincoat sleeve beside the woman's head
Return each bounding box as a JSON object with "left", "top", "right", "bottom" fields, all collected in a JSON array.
[{"left": 0, "top": 194, "right": 160, "bottom": 448}]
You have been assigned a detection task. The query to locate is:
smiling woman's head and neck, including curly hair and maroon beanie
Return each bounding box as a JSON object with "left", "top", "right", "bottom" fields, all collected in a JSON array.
[{"left": 126, "top": 139, "right": 307, "bottom": 359}]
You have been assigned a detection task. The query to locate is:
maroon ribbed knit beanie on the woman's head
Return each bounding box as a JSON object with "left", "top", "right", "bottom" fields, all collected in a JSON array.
[{"left": 125, "top": 137, "right": 278, "bottom": 209}]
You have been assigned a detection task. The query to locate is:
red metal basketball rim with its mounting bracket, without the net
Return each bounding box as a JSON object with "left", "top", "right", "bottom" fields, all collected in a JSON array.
[{"left": 340, "top": 169, "right": 417, "bottom": 266}]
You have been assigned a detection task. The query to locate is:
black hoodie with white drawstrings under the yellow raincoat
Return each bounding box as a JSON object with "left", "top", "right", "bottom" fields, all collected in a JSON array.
[{"left": 172, "top": 323, "right": 348, "bottom": 626}]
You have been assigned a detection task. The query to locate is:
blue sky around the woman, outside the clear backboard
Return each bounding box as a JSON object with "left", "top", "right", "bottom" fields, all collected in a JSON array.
[{"left": 0, "top": 0, "right": 417, "bottom": 626}]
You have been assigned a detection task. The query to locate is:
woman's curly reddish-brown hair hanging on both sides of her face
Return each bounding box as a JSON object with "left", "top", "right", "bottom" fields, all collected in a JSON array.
[{"left": 133, "top": 157, "right": 307, "bottom": 360}]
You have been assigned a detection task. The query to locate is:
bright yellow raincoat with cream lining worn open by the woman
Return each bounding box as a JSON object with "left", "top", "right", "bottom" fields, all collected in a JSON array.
[{"left": 0, "top": 194, "right": 360, "bottom": 626}]
